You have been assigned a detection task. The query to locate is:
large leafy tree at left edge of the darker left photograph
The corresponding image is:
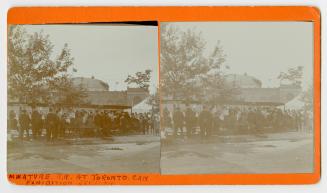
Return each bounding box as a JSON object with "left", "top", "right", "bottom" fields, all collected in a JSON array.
[{"left": 8, "top": 25, "right": 86, "bottom": 104}]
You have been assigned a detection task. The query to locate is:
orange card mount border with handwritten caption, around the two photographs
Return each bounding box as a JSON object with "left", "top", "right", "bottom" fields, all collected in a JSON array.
[{"left": 8, "top": 6, "right": 321, "bottom": 185}]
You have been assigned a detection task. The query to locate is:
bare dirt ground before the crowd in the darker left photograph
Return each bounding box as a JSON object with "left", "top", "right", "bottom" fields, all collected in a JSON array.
[{"left": 7, "top": 135, "right": 160, "bottom": 173}]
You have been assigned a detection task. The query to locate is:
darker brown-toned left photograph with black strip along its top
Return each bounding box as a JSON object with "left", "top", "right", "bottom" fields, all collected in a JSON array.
[{"left": 7, "top": 22, "right": 160, "bottom": 174}]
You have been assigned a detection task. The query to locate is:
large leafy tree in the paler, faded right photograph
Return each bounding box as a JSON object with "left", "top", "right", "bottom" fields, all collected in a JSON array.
[{"left": 160, "top": 24, "right": 226, "bottom": 104}]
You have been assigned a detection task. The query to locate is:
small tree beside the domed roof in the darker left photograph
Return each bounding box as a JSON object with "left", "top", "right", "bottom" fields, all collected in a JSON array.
[{"left": 125, "top": 70, "right": 152, "bottom": 90}]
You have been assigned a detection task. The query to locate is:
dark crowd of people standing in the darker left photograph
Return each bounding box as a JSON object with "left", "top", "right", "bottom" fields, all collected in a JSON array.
[{"left": 8, "top": 108, "right": 159, "bottom": 141}]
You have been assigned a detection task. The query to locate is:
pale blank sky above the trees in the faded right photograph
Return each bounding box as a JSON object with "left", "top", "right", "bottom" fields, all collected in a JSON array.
[{"left": 167, "top": 22, "right": 313, "bottom": 88}]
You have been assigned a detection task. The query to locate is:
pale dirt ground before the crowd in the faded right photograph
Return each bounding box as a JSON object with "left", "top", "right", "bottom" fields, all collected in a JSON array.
[{"left": 161, "top": 132, "right": 313, "bottom": 174}]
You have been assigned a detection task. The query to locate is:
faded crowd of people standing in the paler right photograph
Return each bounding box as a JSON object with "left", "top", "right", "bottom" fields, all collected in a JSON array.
[{"left": 162, "top": 106, "right": 312, "bottom": 137}]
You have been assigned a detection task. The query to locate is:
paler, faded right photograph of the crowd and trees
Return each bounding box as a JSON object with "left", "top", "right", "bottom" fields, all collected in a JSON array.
[{"left": 160, "top": 22, "right": 314, "bottom": 174}]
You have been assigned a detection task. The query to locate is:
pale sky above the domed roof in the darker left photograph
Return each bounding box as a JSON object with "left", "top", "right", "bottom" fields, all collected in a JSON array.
[{"left": 25, "top": 24, "right": 158, "bottom": 93}]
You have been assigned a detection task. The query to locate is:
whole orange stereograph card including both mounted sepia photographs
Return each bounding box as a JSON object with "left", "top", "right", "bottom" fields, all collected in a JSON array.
[{"left": 7, "top": 6, "right": 320, "bottom": 185}]
